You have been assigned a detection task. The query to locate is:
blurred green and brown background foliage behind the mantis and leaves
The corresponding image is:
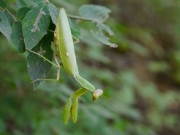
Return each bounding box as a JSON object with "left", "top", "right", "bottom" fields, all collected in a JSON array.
[{"left": 0, "top": 0, "right": 180, "bottom": 135}]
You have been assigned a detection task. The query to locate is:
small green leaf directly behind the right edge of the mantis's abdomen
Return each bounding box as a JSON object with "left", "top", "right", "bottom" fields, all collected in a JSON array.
[{"left": 68, "top": 17, "right": 81, "bottom": 38}]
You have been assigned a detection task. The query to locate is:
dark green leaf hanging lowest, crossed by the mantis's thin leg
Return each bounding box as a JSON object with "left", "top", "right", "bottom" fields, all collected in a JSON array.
[{"left": 27, "top": 35, "right": 53, "bottom": 89}]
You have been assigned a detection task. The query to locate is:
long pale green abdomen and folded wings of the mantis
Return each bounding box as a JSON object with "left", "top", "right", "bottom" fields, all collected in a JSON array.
[{"left": 54, "top": 8, "right": 79, "bottom": 76}]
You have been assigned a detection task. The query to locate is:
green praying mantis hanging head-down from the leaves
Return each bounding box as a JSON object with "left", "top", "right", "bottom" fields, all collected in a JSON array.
[{"left": 28, "top": 8, "right": 103, "bottom": 124}]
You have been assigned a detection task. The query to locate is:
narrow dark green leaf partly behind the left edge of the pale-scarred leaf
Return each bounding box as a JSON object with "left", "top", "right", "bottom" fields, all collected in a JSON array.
[{"left": 11, "top": 22, "right": 25, "bottom": 53}]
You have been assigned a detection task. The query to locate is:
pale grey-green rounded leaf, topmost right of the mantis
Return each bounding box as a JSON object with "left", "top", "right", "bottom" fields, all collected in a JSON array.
[{"left": 79, "top": 4, "right": 111, "bottom": 22}]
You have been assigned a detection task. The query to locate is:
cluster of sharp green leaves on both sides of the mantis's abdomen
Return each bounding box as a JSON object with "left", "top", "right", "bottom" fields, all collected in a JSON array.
[{"left": 0, "top": 0, "right": 117, "bottom": 89}]
